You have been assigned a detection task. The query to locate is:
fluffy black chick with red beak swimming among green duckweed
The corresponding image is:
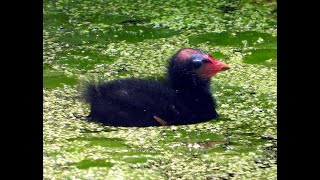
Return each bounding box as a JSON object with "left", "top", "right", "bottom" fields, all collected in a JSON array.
[{"left": 83, "top": 48, "right": 229, "bottom": 127}]
